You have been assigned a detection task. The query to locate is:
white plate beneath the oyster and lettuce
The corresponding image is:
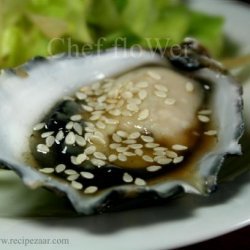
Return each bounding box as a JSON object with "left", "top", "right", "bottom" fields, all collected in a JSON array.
[{"left": 0, "top": 0, "right": 250, "bottom": 250}]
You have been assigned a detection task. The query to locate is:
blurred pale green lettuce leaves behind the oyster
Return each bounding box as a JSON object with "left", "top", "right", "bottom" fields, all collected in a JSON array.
[{"left": 0, "top": 0, "right": 223, "bottom": 68}]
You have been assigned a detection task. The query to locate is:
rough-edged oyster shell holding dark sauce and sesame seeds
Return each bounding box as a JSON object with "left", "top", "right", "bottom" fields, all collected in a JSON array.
[{"left": 0, "top": 40, "right": 243, "bottom": 214}]
